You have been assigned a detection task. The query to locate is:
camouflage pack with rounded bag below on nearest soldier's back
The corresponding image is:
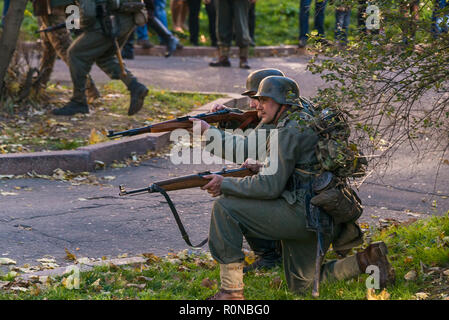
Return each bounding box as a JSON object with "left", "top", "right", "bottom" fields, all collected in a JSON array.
[{"left": 294, "top": 97, "right": 368, "bottom": 224}]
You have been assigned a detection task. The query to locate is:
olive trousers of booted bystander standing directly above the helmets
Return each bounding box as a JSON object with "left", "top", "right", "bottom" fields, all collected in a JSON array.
[{"left": 215, "top": 0, "right": 251, "bottom": 48}]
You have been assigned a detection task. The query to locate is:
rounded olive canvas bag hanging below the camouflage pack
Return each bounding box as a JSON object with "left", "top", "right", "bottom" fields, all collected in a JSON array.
[{"left": 310, "top": 171, "right": 363, "bottom": 224}]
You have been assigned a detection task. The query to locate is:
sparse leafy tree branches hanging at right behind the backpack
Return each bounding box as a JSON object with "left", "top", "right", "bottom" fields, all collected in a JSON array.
[{"left": 308, "top": 0, "right": 449, "bottom": 184}]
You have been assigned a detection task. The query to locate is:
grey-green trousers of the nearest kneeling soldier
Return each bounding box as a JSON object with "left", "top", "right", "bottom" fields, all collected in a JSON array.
[{"left": 209, "top": 196, "right": 360, "bottom": 293}]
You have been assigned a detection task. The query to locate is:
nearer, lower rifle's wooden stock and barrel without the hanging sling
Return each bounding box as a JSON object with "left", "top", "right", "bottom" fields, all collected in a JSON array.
[{"left": 119, "top": 168, "right": 255, "bottom": 196}]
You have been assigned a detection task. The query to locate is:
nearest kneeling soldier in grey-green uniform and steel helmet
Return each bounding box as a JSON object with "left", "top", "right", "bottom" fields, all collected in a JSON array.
[{"left": 204, "top": 76, "right": 393, "bottom": 300}]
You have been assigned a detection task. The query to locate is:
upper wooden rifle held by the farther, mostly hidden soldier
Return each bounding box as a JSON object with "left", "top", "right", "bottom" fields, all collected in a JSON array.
[{"left": 107, "top": 109, "right": 260, "bottom": 138}]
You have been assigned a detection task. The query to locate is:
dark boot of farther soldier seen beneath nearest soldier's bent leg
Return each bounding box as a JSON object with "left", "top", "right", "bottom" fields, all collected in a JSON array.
[{"left": 243, "top": 237, "right": 282, "bottom": 273}]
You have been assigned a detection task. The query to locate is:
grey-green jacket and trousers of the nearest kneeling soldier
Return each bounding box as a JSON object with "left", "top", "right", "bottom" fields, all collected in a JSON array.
[{"left": 209, "top": 110, "right": 361, "bottom": 292}]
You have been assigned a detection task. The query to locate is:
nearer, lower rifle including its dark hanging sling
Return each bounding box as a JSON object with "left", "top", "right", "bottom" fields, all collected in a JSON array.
[{"left": 119, "top": 168, "right": 254, "bottom": 248}]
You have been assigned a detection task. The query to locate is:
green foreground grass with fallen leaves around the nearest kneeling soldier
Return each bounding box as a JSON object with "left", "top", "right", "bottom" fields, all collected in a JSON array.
[{"left": 0, "top": 213, "right": 449, "bottom": 300}]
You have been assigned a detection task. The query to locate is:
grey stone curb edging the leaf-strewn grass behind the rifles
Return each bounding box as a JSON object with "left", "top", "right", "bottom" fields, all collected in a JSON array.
[{"left": 0, "top": 93, "right": 248, "bottom": 175}]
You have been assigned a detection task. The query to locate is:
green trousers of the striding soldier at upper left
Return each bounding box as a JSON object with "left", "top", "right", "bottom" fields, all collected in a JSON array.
[{"left": 68, "top": 15, "right": 136, "bottom": 103}]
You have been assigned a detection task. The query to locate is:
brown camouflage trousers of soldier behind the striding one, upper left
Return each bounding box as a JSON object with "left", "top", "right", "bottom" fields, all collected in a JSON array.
[{"left": 38, "top": 0, "right": 100, "bottom": 99}]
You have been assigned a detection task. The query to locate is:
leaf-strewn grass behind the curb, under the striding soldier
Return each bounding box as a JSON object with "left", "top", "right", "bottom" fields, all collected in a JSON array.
[{"left": 0, "top": 81, "right": 223, "bottom": 153}]
